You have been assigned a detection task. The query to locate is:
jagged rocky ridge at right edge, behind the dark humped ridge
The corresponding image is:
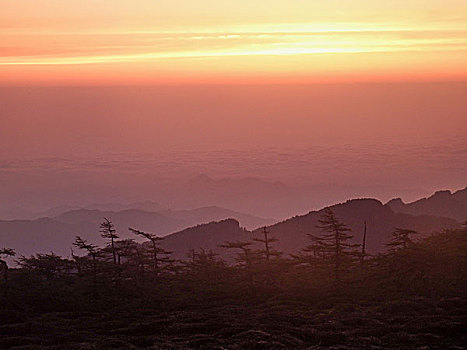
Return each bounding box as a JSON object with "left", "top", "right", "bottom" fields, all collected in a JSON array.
[{"left": 387, "top": 187, "right": 467, "bottom": 222}]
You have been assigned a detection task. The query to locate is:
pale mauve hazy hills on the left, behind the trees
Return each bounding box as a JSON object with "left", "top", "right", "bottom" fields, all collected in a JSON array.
[{"left": 0, "top": 203, "right": 275, "bottom": 255}]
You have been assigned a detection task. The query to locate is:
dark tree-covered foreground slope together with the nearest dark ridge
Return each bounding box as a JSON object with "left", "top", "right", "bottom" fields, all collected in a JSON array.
[{"left": 0, "top": 204, "right": 467, "bottom": 349}]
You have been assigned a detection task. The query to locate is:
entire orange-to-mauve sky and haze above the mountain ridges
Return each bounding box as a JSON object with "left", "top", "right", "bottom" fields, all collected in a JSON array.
[{"left": 0, "top": 0, "right": 467, "bottom": 218}]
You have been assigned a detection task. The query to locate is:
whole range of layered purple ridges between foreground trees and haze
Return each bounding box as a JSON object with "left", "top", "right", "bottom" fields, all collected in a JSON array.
[{"left": 0, "top": 190, "right": 466, "bottom": 259}]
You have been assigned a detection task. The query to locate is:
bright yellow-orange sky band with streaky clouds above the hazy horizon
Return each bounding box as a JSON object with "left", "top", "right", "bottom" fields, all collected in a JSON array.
[{"left": 0, "top": 0, "right": 467, "bottom": 85}]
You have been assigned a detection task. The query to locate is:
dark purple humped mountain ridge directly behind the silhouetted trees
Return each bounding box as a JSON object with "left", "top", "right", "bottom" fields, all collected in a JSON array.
[{"left": 159, "top": 199, "right": 460, "bottom": 259}]
